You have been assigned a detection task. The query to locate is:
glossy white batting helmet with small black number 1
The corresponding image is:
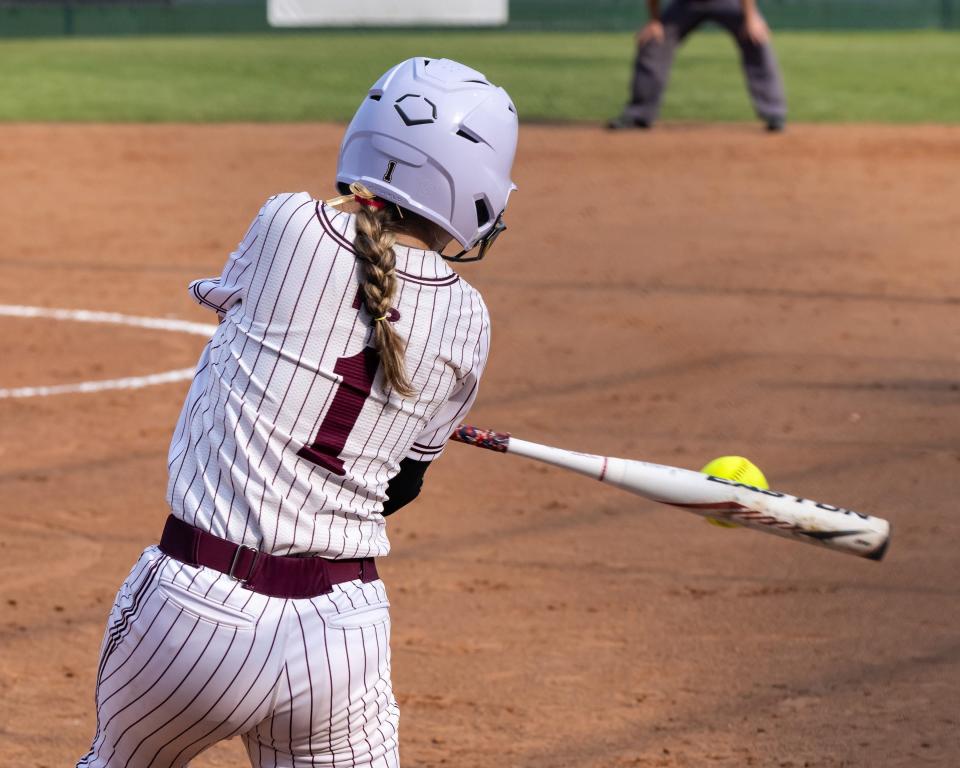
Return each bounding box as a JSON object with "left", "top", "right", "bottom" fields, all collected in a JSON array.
[{"left": 337, "top": 57, "right": 517, "bottom": 255}]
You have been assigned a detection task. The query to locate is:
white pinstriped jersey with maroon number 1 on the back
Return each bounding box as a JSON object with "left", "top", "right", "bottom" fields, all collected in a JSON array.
[{"left": 167, "top": 192, "right": 490, "bottom": 558}]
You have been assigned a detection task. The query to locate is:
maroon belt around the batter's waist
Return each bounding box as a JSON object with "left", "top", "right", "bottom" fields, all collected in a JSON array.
[{"left": 160, "top": 515, "right": 379, "bottom": 599}]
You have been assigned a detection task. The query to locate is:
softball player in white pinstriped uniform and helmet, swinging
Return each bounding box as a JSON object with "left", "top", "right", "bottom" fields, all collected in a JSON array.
[{"left": 78, "top": 58, "right": 517, "bottom": 768}]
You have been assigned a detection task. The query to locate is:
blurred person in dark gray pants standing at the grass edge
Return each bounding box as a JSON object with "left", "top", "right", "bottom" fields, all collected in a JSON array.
[{"left": 607, "top": 0, "right": 787, "bottom": 131}]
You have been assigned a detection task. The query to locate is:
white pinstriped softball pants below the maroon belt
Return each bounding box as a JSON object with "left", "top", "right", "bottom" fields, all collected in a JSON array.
[{"left": 77, "top": 547, "right": 399, "bottom": 768}]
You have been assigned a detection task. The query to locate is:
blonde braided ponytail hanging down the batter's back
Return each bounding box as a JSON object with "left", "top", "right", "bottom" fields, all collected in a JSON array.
[{"left": 353, "top": 205, "right": 416, "bottom": 397}]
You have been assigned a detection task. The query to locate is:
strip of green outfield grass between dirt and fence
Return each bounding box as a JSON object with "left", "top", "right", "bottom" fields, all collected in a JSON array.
[{"left": 0, "top": 32, "right": 960, "bottom": 122}]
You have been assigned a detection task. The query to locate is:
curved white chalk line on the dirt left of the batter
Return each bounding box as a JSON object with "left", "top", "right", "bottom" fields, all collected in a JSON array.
[{"left": 0, "top": 304, "right": 217, "bottom": 400}]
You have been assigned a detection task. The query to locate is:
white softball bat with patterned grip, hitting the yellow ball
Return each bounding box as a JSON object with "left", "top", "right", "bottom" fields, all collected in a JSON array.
[{"left": 451, "top": 424, "right": 890, "bottom": 560}]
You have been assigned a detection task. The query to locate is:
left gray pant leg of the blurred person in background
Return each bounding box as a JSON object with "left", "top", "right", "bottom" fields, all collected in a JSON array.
[{"left": 623, "top": 0, "right": 702, "bottom": 124}]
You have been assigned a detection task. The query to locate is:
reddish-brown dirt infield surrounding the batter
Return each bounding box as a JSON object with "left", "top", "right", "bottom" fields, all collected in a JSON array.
[{"left": 0, "top": 125, "right": 960, "bottom": 768}]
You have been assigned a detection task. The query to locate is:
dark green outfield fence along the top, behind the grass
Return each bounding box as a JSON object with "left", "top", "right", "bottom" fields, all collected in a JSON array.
[{"left": 0, "top": 0, "right": 960, "bottom": 37}]
